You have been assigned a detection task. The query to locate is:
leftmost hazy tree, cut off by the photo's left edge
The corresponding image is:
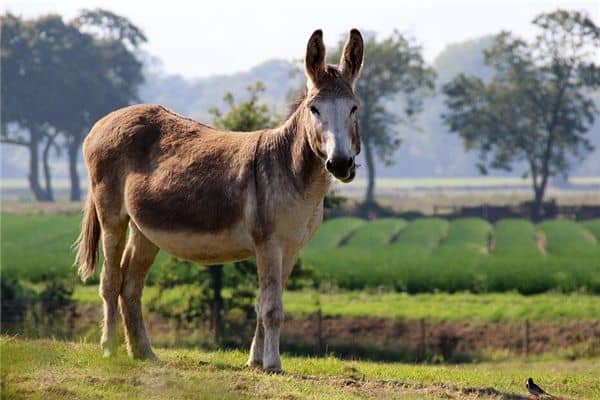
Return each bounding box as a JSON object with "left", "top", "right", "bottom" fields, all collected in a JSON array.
[{"left": 0, "top": 14, "right": 67, "bottom": 201}]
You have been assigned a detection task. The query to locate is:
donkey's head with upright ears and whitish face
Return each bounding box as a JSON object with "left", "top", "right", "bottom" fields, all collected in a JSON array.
[{"left": 300, "top": 29, "right": 363, "bottom": 182}]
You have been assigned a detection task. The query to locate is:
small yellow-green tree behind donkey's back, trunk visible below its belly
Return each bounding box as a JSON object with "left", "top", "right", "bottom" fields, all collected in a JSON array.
[{"left": 208, "top": 81, "right": 278, "bottom": 343}]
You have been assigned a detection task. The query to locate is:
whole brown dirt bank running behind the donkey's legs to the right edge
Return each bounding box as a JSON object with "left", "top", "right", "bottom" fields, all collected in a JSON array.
[{"left": 37, "top": 304, "right": 600, "bottom": 361}]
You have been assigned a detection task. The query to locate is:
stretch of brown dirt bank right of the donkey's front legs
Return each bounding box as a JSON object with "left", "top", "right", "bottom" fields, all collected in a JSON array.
[{"left": 282, "top": 318, "right": 600, "bottom": 356}]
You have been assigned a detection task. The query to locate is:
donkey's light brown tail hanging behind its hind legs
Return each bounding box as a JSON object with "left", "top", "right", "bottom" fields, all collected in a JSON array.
[{"left": 74, "top": 192, "right": 101, "bottom": 282}]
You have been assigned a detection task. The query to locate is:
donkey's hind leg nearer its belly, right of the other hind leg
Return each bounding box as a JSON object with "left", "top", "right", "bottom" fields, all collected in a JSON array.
[{"left": 120, "top": 221, "right": 158, "bottom": 360}]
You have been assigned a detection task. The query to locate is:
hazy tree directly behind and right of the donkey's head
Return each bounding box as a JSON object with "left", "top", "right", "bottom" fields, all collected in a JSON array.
[{"left": 329, "top": 31, "right": 435, "bottom": 207}]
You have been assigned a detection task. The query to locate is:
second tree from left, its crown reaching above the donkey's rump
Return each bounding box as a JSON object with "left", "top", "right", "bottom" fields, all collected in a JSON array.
[{"left": 64, "top": 9, "right": 146, "bottom": 201}]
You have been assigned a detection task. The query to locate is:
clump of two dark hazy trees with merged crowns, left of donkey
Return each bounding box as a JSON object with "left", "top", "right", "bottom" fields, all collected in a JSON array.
[{"left": 1, "top": 10, "right": 146, "bottom": 201}]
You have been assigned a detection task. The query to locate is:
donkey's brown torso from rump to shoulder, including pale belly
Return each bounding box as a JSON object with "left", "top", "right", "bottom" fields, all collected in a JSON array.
[{"left": 84, "top": 104, "right": 259, "bottom": 263}]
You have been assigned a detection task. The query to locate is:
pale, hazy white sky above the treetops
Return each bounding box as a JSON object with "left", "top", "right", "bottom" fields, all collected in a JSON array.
[{"left": 2, "top": 0, "right": 600, "bottom": 77}]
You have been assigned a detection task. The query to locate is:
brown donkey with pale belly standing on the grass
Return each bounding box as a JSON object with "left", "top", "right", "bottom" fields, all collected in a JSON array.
[{"left": 76, "top": 29, "right": 364, "bottom": 372}]
